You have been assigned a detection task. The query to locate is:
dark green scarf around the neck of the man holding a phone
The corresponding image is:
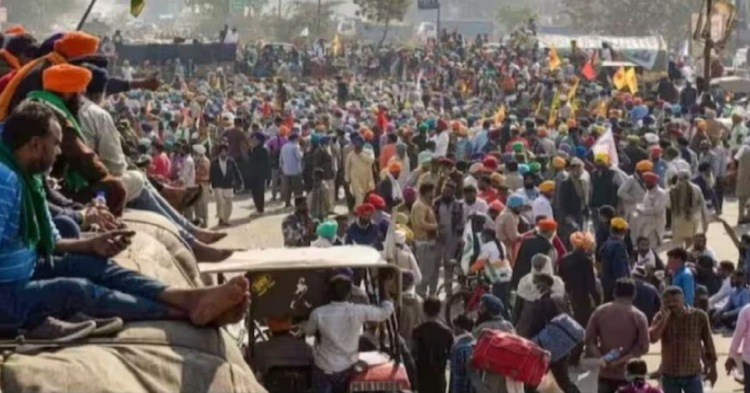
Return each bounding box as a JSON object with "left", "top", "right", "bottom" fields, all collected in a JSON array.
[{"left": 0, "top": 143, "right": 55, "bottom": 256}]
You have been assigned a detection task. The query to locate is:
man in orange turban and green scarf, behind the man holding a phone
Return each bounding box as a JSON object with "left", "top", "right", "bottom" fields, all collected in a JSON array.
[{"left": 29, "top": 64, "right": 127, "bottom": 216}]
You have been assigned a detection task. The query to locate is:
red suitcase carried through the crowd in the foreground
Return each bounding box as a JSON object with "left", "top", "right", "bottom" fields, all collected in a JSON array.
[{"left": 471, "top": 330, "right": 550, "bottom": 386}]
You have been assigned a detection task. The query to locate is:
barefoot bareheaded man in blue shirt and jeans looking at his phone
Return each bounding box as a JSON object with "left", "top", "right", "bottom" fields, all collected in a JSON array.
[{"left": 0, "top": 101, "right": 249, "bottom": 338}]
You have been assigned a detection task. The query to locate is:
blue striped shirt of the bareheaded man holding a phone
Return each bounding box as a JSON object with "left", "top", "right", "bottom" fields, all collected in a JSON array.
[{"left": 0, "top": 163, "right": 60, "bottom": 283}]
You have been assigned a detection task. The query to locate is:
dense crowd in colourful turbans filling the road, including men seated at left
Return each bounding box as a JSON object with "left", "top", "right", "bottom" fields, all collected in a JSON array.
[{"left": 0, "top": 16, "right": 750, "bottom": 393}]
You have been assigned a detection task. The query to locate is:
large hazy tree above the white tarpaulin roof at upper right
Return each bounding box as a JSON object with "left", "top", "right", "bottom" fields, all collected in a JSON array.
[{"left": 563, "top": 0, "right": 703, "bottom": 42}]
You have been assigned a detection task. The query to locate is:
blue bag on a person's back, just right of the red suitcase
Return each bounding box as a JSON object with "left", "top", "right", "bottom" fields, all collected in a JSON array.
[{"left": 533, "top": 313, "right": 586, "bottom": 363}]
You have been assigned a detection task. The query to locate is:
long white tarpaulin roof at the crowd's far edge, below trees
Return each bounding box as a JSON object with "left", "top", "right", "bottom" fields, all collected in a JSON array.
[{"left": 537, "top": 34, "right": 667, "bottom": 70}]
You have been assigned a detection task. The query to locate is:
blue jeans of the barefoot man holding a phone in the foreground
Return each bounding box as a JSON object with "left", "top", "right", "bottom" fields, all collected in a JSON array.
[{"left": 0, "top": 254, "right": 169, "bottom": 334}]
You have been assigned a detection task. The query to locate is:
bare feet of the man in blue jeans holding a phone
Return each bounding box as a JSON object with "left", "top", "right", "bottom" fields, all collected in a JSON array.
[{"left": 190, "top": 276, "right": 250, "bottom": 326}]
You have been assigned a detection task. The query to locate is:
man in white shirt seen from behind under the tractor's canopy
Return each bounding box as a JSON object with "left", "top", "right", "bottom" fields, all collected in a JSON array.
[{"left": 304, "top": 275, "right": 394, "bottom": 393}]
